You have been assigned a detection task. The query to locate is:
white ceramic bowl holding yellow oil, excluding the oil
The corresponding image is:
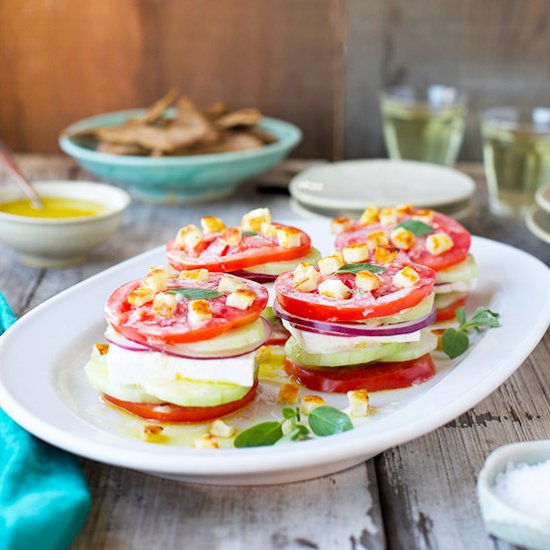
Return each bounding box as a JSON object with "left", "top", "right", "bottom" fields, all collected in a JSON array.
[{"left": 0, "top": 181, "right": 130, "bottom": 268}]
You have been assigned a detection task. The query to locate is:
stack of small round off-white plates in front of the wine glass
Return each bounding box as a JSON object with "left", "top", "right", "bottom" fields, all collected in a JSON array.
[{"left": 289, "top": 160, "right": 475, "bottom": 218}]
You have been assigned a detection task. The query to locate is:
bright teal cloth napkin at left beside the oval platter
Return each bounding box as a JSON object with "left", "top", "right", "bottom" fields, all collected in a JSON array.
[{"left": 0, "top": 293, "right": 90, "bottom": 550}]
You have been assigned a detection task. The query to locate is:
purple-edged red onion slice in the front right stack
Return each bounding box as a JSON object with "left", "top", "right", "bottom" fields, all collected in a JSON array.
[{"left": 273, "top": 300, "right": 437, "bottom": 336}]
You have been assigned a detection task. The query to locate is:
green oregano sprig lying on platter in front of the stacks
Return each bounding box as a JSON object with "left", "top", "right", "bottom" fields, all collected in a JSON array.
[{"left": 233, "top": 405, "right": 353, "bottom": 447}]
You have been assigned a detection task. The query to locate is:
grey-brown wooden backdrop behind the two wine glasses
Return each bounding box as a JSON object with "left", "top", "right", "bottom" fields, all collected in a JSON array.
[{"left": 344, "top": 0, "right": 550, "bottom": 160}]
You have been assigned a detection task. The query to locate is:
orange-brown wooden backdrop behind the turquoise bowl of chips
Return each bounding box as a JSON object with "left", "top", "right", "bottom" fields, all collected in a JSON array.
[{"left": 0, "top": 0, "right": 343, "bottom": 157}]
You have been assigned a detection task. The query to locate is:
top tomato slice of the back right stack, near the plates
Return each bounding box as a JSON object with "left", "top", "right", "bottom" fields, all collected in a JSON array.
[{"left": 335, "top": 212, "right": 472, "bottom": 271}]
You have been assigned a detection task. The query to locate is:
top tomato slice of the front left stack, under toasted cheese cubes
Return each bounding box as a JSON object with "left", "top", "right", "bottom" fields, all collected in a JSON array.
[{"left": 105, "top": 273, "right": 268, "bottom": 345}]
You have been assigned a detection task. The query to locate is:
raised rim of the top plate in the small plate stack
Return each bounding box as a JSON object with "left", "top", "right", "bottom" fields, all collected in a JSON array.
[{"left": 289, "top": 159, "right": 476, "bottom": 210}]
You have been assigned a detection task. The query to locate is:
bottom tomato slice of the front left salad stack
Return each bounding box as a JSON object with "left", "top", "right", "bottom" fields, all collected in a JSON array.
[{"left": 103, "top": 381, "right": 258, "bottom": 422}]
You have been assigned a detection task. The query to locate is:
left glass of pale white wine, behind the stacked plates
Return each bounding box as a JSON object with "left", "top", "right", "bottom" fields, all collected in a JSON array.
[{"left": 380, "top": 84, "right": 468, "bottom": 166}]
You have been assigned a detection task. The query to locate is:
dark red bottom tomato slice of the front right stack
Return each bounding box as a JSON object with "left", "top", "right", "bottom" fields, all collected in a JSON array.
[{"left": 284, "top": 353, "right": 436, "bottom": 393}]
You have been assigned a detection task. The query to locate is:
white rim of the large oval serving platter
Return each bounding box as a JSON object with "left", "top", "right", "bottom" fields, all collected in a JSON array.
[{"left": 0, "top": 229, "right": 550, "bottom": 476}]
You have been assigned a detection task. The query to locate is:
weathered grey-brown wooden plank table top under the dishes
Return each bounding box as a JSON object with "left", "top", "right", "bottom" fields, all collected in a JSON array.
[{"left": 0, "top": 155, "right": 550, "bottom": 550}]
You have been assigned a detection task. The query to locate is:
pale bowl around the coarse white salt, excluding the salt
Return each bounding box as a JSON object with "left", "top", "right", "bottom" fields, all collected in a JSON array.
[{"left": 477, "top": 440, "right": 550, "bottom": 550}]
